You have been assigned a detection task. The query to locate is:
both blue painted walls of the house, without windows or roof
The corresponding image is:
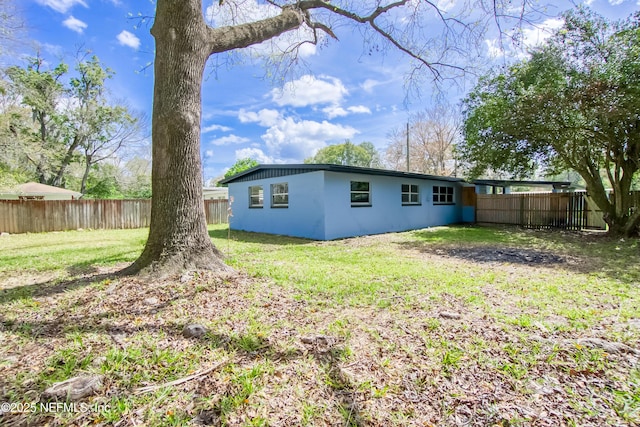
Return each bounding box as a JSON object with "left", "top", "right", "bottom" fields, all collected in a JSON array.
[{"left": 229, "top": 171, "right": 463, "bottom": 240}]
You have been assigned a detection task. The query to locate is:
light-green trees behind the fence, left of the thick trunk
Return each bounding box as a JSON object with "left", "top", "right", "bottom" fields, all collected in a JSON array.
[{"left": 0, "top": 56, "right": 145, "bottom": 193}]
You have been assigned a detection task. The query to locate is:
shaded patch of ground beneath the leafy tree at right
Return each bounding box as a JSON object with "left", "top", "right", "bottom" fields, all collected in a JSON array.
[{"left": 399, "top": 226, "right": 640, "bottom": 283}]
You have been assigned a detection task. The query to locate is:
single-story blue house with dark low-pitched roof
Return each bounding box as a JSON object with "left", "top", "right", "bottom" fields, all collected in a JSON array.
[{"left": 221, "top": 164, "right": 475, "bottom": 240}]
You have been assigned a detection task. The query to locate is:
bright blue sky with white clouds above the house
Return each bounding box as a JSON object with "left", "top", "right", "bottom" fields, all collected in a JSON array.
[{"left": 14, "top": 0, "right": 640, "bottom": 180}]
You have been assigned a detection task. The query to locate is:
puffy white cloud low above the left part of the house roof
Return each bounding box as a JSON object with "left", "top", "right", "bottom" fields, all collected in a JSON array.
[{"left": 239, "top": 110, "right": 358, "bottom": 162}]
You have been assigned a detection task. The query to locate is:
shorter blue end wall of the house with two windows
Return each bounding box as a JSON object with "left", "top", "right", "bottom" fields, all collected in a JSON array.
[{"left": 229, "top": 171, "right": 325, "bottom": 240}]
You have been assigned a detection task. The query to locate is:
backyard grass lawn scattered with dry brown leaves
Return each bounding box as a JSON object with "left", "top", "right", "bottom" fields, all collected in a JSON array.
[{"left": 0, "top": 226, "right": 640, "bottom": 426}]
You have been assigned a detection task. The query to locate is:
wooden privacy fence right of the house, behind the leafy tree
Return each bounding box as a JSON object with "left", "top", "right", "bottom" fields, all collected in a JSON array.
[{"left": 476, "top": 191, "right": 620, "bottom": 230}]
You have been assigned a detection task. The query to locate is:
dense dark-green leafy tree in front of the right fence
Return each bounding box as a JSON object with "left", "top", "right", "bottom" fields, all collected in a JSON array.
[{"left": 459, "top": 8, "right": 640, "bottom": 235}]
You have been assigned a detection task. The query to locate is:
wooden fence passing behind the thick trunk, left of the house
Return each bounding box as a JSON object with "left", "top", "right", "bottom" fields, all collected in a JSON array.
[{"left": 0, "top": 199, "right": 228, "bottom": 233}]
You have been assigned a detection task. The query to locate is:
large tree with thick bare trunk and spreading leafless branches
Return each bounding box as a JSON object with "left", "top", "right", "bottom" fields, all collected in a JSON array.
[{"left": 127, "top": 0, "right": 548, "bottom": 274}]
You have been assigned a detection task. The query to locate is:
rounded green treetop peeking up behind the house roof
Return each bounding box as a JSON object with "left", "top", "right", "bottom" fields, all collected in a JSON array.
[{"left": 304, "top": 140, "right": 380, "bottom": 168}]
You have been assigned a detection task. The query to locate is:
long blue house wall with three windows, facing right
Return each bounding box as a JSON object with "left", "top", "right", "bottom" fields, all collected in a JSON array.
[{"left": 325, "top": 172, "right": 462, "bottom": 240}]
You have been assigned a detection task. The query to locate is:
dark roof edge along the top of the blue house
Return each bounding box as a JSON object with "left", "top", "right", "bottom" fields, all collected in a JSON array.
[{"left": 220, "top": 163, "right": 464, "bottom": 184}]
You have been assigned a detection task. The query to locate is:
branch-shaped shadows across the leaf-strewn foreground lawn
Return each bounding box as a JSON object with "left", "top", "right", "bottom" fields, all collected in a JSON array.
[{"left": 0, "top": 292, "right": 366, "bottom": 427}]
